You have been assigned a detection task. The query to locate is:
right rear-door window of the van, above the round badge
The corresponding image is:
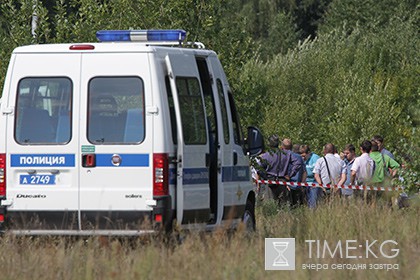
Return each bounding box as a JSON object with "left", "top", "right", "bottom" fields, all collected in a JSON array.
[{"left": 87, "top": 77, "right": 145, "bottom": 145}]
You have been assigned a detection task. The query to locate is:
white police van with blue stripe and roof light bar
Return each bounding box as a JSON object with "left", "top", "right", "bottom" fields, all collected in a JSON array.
[{"left": 0, "top": 30, "right": 262, "bottom": 235}]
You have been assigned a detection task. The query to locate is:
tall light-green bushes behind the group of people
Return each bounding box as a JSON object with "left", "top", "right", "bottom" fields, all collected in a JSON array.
[{"left": 241, "top": 5, "right": 420, "bottom": 192}]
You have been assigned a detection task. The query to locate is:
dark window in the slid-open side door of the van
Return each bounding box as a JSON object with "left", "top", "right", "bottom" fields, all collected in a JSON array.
[{"left": 176, "top": 78, "right": 207, "bottom": 145}]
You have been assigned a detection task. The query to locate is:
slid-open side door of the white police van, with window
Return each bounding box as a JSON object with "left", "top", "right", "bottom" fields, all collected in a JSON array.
[{"left": 166, "top": 54, "right": 210, "bottom": 223}]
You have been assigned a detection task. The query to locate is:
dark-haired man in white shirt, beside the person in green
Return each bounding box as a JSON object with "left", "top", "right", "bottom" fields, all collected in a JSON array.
[{"left": 350, "top": 140, "right": 374, "bottom": 185}]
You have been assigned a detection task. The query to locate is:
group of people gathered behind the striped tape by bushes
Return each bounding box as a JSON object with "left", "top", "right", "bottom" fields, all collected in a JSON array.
[{"left": 253, "top": 135, "right": 400, "bottom": 208}]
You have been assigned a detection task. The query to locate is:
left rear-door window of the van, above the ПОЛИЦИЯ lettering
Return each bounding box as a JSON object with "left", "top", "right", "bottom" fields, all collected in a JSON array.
[{"left": 14, "top": 77, "right": 73, "bottom": 145}]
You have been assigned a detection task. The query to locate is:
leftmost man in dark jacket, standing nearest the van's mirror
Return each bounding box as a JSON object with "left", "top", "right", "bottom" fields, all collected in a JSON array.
[{"left": 259, "top": 135, "right": 301, "bottom": 205}]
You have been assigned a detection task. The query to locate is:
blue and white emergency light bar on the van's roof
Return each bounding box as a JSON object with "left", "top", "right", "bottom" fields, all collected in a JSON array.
[{"left": 96, "top": 29, "right": 187, "bottom": 42}]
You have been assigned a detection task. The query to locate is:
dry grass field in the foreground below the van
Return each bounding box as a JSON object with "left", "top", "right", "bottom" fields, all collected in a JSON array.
[{"left": 0, "top": 195, "right": 420, "bottom": 279}]
